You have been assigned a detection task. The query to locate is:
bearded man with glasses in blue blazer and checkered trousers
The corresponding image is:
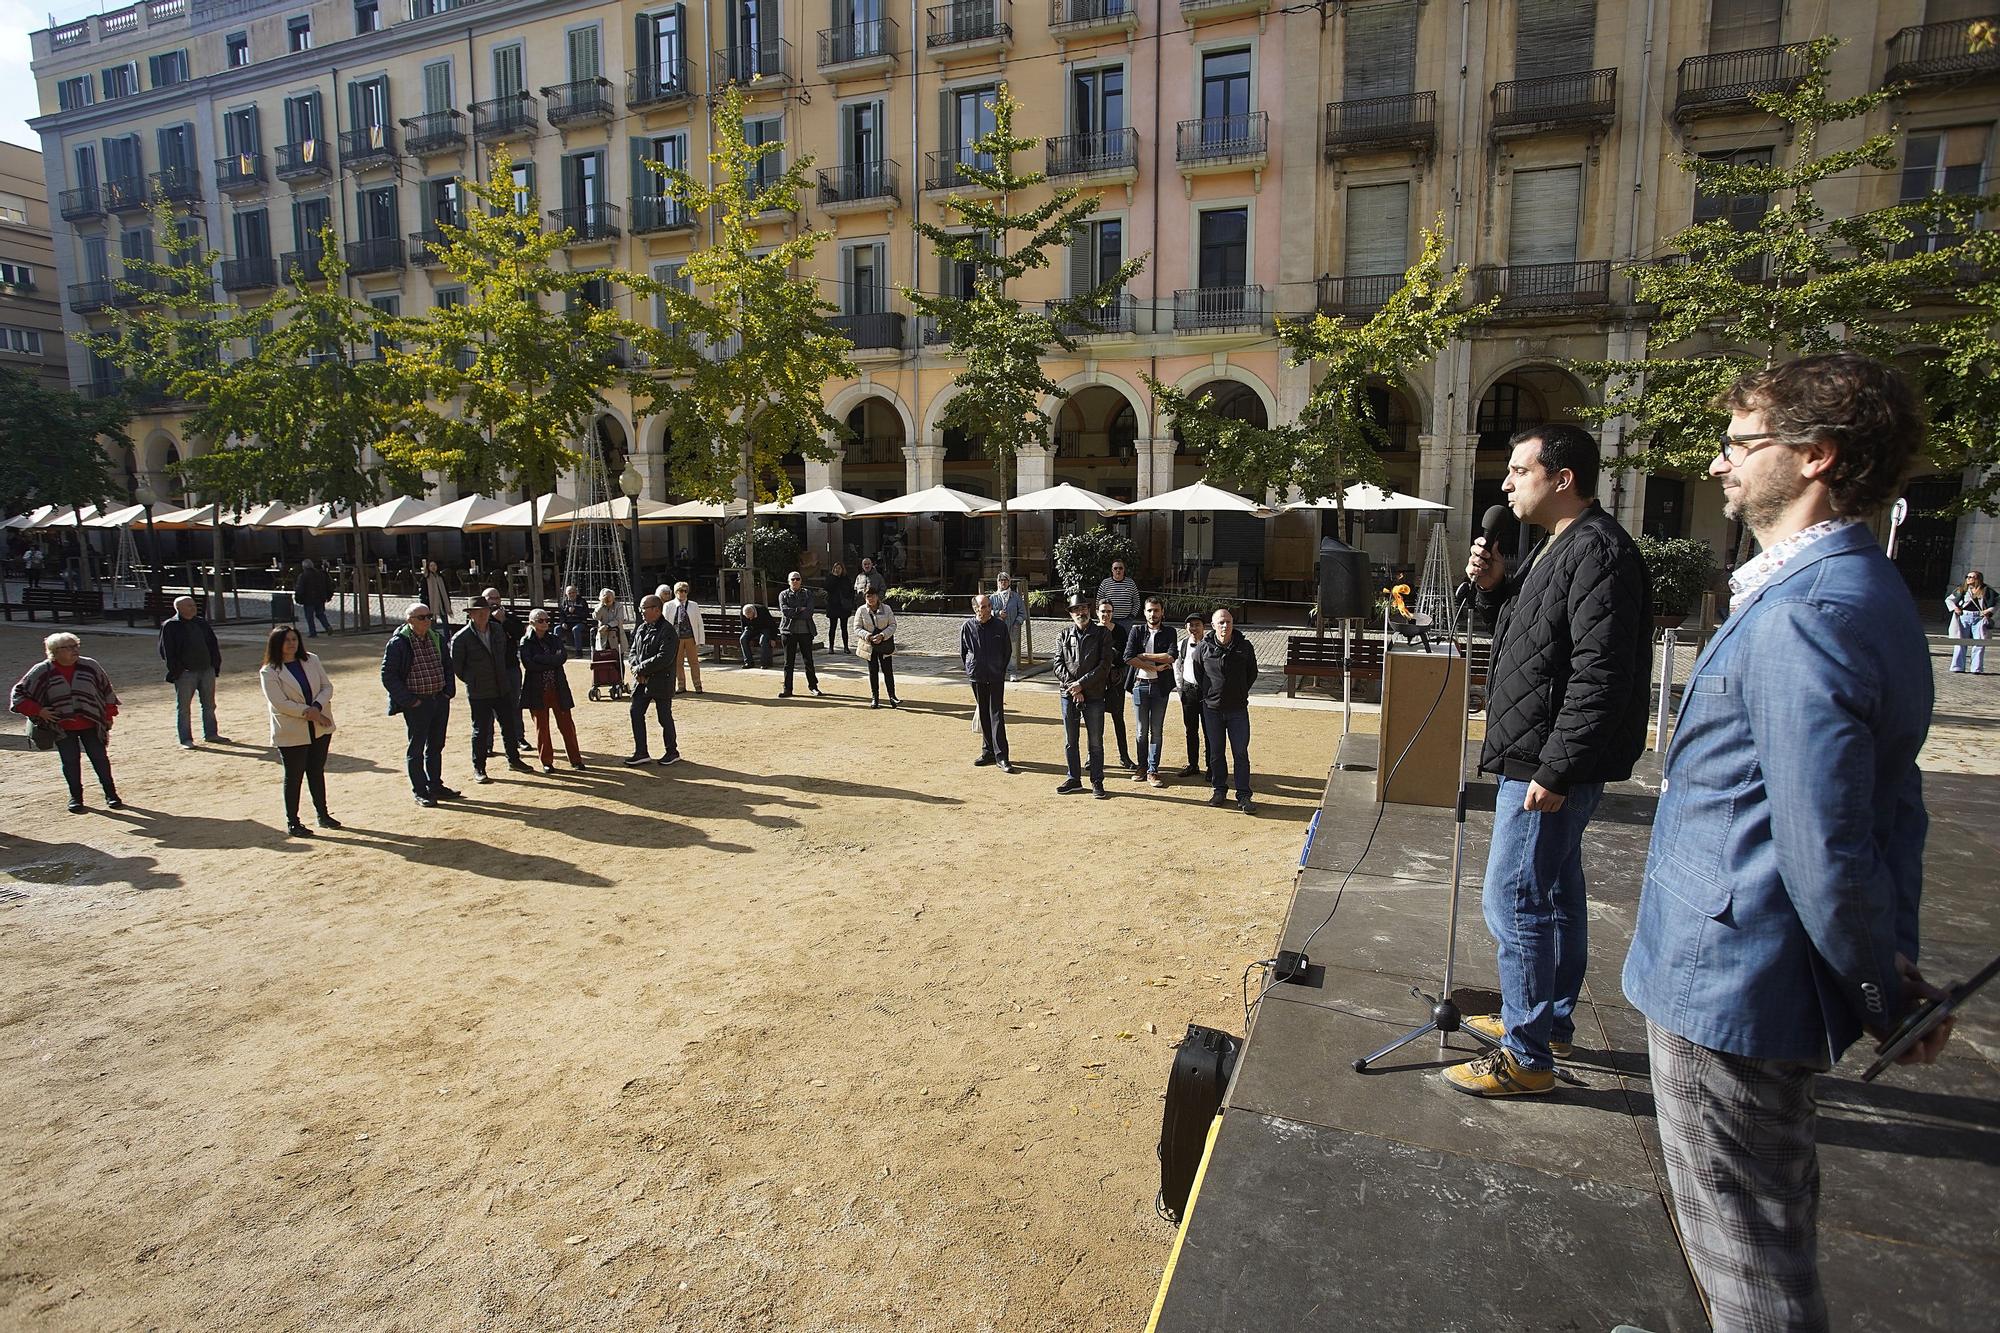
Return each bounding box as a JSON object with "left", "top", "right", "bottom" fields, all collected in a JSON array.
[{"left": 1624, "top": 352, "right": 1944, "bottom": 1331}]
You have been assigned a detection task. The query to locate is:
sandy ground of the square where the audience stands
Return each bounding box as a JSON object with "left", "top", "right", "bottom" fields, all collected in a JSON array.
[{"left": 0, "top": 626, "right": 1344, "bottom": 1333}]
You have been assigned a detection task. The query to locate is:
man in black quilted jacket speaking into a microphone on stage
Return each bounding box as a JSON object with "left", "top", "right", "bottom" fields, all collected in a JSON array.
[{"left": 1444, "top": 424, "right": 1652, "bottom": 1097}]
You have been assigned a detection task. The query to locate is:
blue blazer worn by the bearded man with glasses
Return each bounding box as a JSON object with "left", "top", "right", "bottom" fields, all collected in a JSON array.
[{"left": 1624, "top": 526, "right": 1932, "bottom": 1063}]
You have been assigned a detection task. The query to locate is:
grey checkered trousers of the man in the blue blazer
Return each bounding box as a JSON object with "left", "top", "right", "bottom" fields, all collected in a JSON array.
[{"left": 1646, "top": 1023, "right": 1828, "bottom": 1333}]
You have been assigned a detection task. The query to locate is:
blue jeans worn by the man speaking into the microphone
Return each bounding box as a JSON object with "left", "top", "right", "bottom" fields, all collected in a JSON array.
[{"left": 1482, "top": 779, "right": 1604, "bottom": 1069}]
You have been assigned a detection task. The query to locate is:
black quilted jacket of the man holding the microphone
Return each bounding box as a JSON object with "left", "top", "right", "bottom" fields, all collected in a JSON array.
[{"left": 1478, "top": 504, "right": 1652, "bottom": 793}]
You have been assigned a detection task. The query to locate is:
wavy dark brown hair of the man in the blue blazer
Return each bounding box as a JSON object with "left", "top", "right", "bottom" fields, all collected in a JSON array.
[{"left": 1716, "top": 352, "right": 1924, "bottom": 518}]
